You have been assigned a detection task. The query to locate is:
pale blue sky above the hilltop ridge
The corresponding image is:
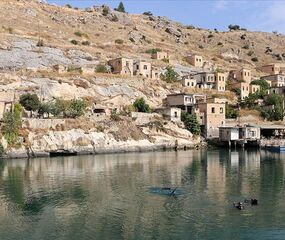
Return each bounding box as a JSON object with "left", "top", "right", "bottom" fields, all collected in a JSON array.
[{"left": 47, "top": 0, "right": 285, "bottom": 33}]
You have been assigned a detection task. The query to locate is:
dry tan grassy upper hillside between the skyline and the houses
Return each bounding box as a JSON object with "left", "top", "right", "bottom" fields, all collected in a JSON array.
[{"left": 0, "top": 0, "right": 285, "bottom": 72}]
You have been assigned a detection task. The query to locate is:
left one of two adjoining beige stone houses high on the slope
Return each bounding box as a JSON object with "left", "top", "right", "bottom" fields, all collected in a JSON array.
[{"left": 108, "top": 58, "right": 134, "bottom": 76}]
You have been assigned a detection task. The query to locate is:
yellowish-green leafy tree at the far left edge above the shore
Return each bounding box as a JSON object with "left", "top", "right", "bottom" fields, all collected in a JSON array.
[{"left": 1, "top": 104, "right": 23, "bottom": 144}]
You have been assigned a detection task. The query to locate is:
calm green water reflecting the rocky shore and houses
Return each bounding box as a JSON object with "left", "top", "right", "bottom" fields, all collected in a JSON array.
[{"left": 0, "top": 150, "right": 285, "bottom": 240}]
